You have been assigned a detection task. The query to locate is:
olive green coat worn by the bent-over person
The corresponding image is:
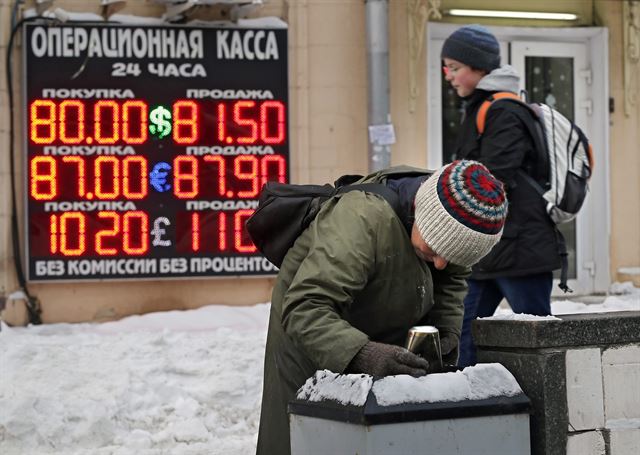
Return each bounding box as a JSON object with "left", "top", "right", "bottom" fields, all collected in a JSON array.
[{"left": 258, "top": 167, "right": 470, "bottom": 455}]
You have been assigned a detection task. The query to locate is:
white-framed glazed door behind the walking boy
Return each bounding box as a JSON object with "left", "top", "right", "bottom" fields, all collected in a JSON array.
[{"left": 427, "top": 24, "right": 609, "bottom": 296}]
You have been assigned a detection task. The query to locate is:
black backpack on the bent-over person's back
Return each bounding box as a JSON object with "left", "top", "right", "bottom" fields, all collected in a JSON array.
[{"left": 245, "top": 175, "right": 400, "bottom": 267}]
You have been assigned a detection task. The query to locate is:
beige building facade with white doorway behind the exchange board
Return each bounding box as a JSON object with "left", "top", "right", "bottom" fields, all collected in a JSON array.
[{"left": 0, "top": 0, "right": 640, "bottom": 322}]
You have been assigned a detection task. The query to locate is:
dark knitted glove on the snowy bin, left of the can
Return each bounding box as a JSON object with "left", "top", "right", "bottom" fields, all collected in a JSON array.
[{"left": 347, "top": 341, "right": 429, "bottom": 376}]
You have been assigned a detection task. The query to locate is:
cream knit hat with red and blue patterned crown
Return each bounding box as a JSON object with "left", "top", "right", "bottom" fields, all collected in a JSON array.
[{"left": 415, "top": 160, "right": 507, "bottom": 267}]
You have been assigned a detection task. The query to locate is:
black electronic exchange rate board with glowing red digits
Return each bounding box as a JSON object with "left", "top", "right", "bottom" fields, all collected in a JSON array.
[{"left": 24, "top": 24, "right": 289, "bottom": 281}]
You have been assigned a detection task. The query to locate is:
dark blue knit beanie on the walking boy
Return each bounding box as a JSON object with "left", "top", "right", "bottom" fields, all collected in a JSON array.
[{"left": 440, "top": 24, "right": 500, "bottom": 72}]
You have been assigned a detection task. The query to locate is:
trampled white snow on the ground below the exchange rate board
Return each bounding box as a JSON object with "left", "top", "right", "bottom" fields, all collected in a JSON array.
[{"left": 0, "top": 285, "right": 640, "bottom": 455}]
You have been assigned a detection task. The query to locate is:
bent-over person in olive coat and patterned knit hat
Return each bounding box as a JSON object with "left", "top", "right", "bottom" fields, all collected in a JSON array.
[{"left": 257, "top": 161, "right": 507, "bottom": 455}]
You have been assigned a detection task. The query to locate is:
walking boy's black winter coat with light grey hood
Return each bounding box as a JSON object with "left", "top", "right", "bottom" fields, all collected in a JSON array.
[{"left": 456, "top": 66, "right": 561, "bottom": 279}]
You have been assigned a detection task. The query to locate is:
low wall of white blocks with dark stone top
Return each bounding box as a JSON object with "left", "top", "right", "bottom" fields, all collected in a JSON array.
[{"left": 472, "top": 311, "right": 640, "bottom": 455}]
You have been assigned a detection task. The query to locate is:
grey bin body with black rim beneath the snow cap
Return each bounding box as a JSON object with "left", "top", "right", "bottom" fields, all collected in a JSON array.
[{"left": 289, "top": 364, "right": 530, "bottom": 455}]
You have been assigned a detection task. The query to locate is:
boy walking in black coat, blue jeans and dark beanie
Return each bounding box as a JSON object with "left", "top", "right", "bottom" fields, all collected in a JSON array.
[{"left": 441, "top": 25, "right": 562, "bottom": 366}]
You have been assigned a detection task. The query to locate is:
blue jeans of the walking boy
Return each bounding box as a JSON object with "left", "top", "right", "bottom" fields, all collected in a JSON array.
[{"left": 458, "top": 272, "right": 553, "bottom": 367}]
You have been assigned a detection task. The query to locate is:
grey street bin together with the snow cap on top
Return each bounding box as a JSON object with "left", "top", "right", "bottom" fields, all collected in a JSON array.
[{"left": 289, "top": 364, "right": 530, "bottom": 455}]
